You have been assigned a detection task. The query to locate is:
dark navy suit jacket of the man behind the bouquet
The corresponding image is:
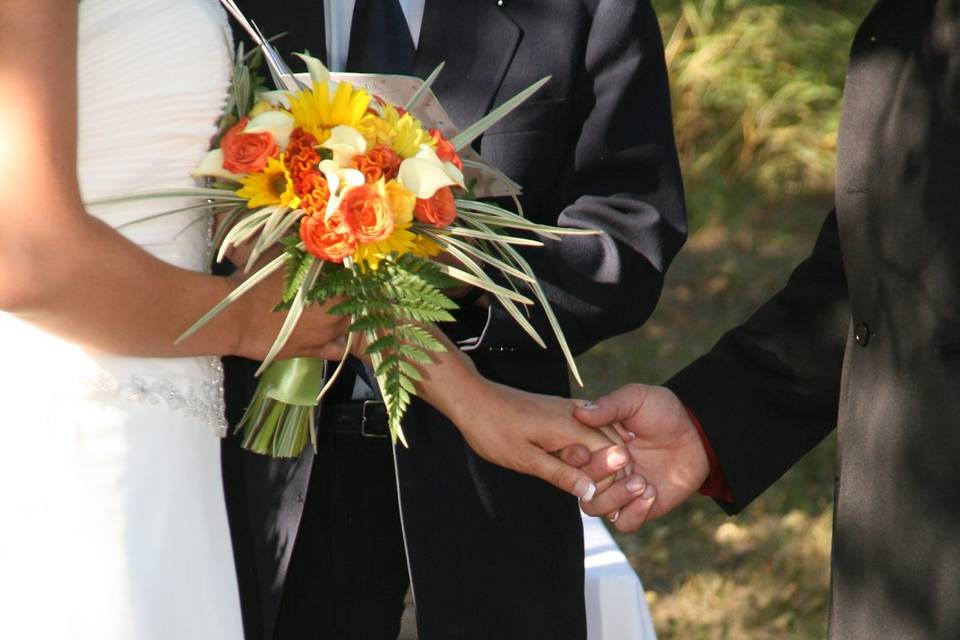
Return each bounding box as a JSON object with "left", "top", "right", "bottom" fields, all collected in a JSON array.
[{"left": 224, "top": 0, "right": 686, "bottom": 640}]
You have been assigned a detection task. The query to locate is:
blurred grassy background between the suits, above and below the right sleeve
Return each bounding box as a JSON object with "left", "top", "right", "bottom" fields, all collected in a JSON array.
[{"left": 579, "top": 0, "right": 873, "bottom": 640}]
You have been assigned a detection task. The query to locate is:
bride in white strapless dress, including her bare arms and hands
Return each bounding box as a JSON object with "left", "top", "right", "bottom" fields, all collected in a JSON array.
[{"left": 0, "top": 0, "right": 632, "bottom": 640}]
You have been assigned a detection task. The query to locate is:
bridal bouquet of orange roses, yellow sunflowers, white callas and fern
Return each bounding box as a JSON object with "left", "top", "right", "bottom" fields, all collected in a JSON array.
[{"left": 94, "top": 3, "right": 593, "bottom": 457}]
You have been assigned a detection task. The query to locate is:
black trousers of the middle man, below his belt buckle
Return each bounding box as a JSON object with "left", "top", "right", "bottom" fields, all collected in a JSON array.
[{"left": 274, "top": 428, "right": 409, "bottom": 640}]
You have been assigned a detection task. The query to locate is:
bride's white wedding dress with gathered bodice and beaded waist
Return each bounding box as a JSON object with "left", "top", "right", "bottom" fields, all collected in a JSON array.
[{"left": 0, "top": 0, "right": 243, "bottom": 640}]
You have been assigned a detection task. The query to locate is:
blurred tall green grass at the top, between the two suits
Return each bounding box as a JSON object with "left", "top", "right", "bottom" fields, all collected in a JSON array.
[{"left": 654, "top": 0, "right": 872, "bottom": 228}]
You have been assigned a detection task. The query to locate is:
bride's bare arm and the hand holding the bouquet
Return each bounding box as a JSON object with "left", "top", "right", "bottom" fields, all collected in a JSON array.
[{"left": 0, "top": 0, "right": 344, "bottom": 358}]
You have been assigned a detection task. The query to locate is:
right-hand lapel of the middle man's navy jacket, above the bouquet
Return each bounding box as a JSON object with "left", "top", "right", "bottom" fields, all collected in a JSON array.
[{"left": 414, "top": 0, "right": 522, "bottom": 128}]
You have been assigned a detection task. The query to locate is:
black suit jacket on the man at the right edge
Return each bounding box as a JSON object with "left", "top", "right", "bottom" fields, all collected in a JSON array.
[{"left": 668, "top": 0, "right": 960, "bottom": 640}]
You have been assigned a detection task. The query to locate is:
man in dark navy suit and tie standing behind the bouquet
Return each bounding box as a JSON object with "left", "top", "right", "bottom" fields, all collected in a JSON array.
[{"left": 224, "top": 0, "right": 686, "bottom": 640}]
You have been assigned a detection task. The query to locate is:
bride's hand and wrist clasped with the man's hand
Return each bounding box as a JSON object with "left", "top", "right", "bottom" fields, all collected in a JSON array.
[{"left": 438, "top": 376, "right": 709, "bottom": 532}]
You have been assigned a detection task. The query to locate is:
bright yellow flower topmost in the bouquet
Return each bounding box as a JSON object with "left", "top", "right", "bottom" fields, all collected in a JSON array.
[{"left": 290, "top": 82, "right": 370, "bottom": 143}]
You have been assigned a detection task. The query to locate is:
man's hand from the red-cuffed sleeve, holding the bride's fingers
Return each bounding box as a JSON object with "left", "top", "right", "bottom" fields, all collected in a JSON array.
[{"left": 575, "top": 384, "right": 710, "bottom": 532}]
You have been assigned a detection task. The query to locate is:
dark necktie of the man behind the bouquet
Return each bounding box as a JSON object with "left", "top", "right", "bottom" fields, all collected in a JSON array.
[{"left": 347, "top": 0, "right": 416, "bottom": 75}]
